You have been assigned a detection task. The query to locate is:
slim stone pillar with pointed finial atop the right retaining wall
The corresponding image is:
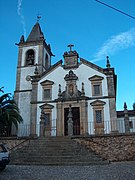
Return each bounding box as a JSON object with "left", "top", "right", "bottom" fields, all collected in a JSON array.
[{"left": 124, "top": 103, "right": 130, "bottom": 133}]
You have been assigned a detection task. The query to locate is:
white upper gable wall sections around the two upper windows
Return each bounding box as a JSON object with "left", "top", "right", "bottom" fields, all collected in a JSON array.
[{"left": 38, "top": 64, "right": 108, "bottom": 100}]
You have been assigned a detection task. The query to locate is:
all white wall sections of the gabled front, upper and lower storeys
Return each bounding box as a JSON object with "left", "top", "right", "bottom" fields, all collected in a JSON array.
[{"left": 37, "top": 64, "right": 110, "bottom": 135}]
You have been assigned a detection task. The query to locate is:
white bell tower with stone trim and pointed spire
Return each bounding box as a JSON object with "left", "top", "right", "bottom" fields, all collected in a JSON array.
[{"left": 14, "top": 22, "right": 53, "bottom": 130}]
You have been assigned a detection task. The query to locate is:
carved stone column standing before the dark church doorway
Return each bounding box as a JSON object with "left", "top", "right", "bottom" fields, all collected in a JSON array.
[{"left": 68, "top": 104, "right": 73, "bottom": 136}]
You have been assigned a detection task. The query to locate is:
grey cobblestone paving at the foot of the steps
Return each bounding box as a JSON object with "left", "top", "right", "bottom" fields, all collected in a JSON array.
[{"left": 0, "top": 162, "right": 135, "bottom": 180}]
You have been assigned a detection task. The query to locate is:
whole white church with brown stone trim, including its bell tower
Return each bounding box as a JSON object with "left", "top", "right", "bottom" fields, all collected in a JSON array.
[{"left": 14, "top": 22, "right": 118, "bottom": 136}]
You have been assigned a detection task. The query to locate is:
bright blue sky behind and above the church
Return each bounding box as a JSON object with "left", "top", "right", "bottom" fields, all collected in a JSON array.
[{"left": 0, "top": 0, "right": 135, "bottom": 110}]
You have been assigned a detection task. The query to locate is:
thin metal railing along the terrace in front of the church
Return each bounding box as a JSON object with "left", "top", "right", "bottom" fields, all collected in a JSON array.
[{"left": 0, "top": 119, "right": 135, "bottom": 137}]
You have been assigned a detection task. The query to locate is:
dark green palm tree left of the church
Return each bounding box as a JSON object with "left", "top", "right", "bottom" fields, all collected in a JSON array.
[{"left": 0, "top": 87, "right": 23, "bottom": 135}]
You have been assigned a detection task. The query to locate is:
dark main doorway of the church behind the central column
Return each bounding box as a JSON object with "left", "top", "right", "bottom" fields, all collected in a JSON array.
[{"left": 64, "top": 107, "right": 80, "bottom": 136}]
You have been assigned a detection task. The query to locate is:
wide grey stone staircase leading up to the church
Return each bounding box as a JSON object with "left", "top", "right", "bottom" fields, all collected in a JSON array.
[{"left": 10, "top": 137, "right": 107, "bottom": 165}]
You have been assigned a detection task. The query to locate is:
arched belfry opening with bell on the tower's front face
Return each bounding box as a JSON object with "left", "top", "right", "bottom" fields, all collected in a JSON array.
[{"left": 26, "top": 49, "right": 35, "bottom": 66}]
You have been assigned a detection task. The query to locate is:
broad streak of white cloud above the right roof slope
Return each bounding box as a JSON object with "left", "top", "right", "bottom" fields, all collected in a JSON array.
[{"left": 93, "top": 28, "right": 135, "bottom": 62}]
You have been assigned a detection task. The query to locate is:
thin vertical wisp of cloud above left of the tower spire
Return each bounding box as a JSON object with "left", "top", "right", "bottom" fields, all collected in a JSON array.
[{"left": 17, "top": 0, "right": 26, "bottom": 37}]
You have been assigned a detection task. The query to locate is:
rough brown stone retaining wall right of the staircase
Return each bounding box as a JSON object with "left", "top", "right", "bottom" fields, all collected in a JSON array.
[{"left": 75, "top": 134, "right": 135, "bottom": 161}]
